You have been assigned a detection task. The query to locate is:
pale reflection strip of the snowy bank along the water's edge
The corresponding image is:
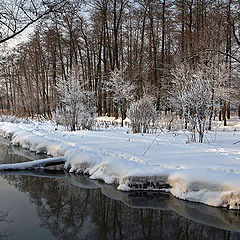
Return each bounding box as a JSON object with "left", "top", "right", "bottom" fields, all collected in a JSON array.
[{"left": 67, "top": 173, "right": 240, "bottom": 232}]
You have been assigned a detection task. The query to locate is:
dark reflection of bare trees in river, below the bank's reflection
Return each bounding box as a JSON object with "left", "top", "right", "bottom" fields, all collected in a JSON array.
[{"left": 2, "top": 176, "right": 240, "bottom": 240}]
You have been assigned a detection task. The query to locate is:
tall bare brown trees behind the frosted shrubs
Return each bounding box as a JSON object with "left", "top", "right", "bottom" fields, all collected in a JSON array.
[{"left": 0, "top": 0, "right": 240, "bottom": 119}]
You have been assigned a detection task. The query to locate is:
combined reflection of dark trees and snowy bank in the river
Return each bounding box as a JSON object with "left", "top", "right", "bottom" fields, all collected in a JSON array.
[{"left": 0, "top": 171, "right": 240, "bottom": 239}]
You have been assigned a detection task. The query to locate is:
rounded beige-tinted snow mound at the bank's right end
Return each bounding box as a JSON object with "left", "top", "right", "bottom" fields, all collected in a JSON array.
[{"left": 168, "top": 169, "right": 240, "bottom": 209}]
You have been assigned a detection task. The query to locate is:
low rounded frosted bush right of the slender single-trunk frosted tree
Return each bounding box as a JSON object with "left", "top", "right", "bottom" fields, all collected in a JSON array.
[{"left": 127, "top": 96, "right": 158, "bottom": 133}]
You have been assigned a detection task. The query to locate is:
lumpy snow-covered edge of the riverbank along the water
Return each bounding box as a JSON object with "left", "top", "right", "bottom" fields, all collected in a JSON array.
[{"left": 0, "top": 123, "right": 240, "bottom": 209}]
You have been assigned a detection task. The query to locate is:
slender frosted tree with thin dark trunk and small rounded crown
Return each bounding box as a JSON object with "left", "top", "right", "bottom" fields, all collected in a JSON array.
[{"left": 105, "top": 70, "right": 135, "bottom": 127}]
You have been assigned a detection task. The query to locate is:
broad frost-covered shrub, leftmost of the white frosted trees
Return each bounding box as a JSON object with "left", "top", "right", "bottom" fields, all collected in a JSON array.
[{"left": 55, "top": 71, "right": 96, "bottom": 131}]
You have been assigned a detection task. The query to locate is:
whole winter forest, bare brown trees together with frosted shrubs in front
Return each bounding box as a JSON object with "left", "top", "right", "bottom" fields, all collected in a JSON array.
[{"left": 0, "top": 0, "right": 240, "bottom": 142}]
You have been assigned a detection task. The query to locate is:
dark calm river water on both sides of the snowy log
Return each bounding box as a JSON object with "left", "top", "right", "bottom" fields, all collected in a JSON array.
[{"left": 0, "top": 138, "right": 240, "bottom": 240}]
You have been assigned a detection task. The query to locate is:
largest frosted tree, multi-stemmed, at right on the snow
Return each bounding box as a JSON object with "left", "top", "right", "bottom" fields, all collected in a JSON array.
[{"left": 172, "top": 61, "right": 228, "bottom": 142}]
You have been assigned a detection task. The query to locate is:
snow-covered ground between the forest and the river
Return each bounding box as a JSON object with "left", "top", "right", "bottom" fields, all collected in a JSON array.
[{"left": 0, "top": 119, "right": 240, "bottom": 209}]
